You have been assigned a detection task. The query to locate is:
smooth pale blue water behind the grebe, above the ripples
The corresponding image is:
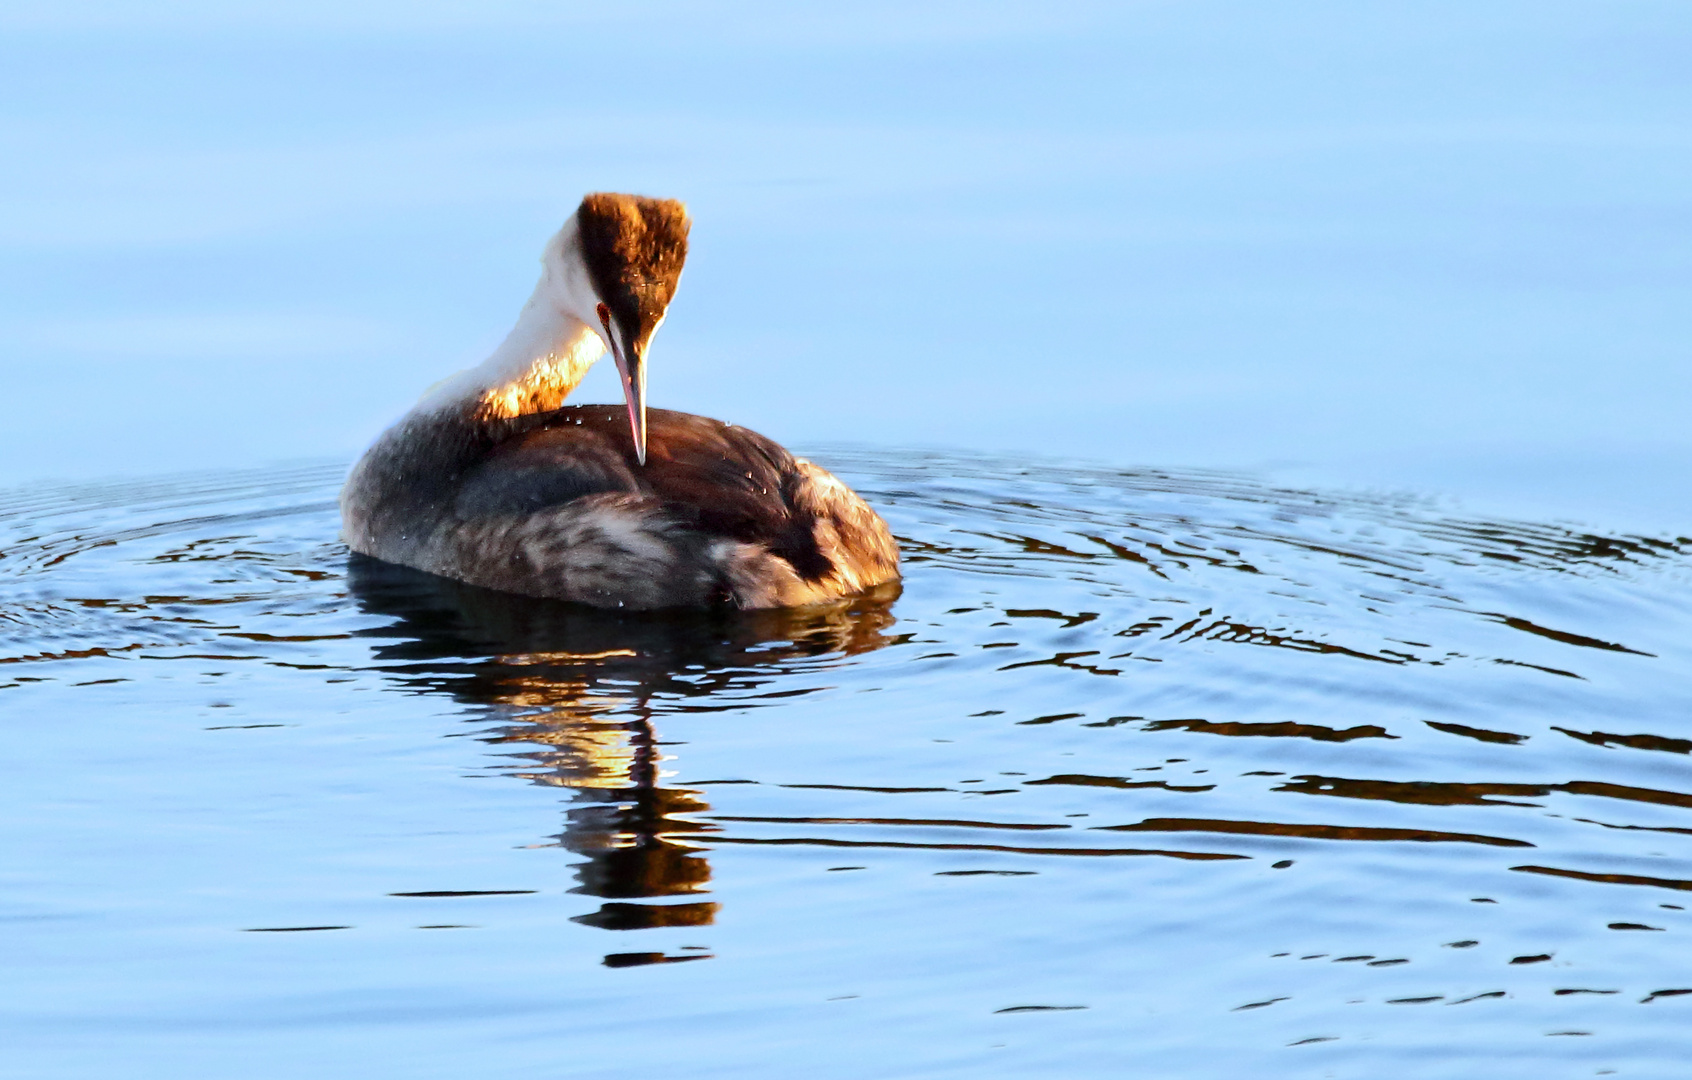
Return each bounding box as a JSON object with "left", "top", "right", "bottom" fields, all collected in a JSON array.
[{"left": 0, "top": 0, "right": 1692, "bottom": 530}]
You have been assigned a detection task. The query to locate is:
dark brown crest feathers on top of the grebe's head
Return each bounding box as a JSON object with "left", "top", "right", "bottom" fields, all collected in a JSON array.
[{"left": 575, "top": 191, "right": 690, "bottom": 349}]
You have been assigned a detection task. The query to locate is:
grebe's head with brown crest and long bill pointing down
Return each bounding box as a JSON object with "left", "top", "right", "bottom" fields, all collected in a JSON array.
[{"left": 545, "top": 193, "right": 690, "bottom": 464}]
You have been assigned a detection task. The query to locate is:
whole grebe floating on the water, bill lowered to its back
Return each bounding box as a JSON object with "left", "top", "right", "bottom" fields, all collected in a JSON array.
[{"left": 340, "top": 195, "right": 898, "bottom": 609}]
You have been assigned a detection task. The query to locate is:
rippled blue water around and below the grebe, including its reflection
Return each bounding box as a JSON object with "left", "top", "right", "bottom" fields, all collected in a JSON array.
[{"left": 0, "top": 450, "right": 1692, "bottom": 1080}]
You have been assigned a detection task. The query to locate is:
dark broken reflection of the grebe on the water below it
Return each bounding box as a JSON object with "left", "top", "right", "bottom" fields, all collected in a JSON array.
[{"left": 349, "top": 555, "right": 898, "bottom": 934}]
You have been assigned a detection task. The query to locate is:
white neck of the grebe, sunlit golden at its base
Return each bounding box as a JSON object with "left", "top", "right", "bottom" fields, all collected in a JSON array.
[{"left": 413, "top": 276, "right": 606, "bottom": 420}]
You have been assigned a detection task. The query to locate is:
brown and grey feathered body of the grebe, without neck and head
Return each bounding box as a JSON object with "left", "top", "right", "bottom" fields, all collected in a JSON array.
[{"left": 342, "top": 405, "right": 898, "bottom": 608}]
